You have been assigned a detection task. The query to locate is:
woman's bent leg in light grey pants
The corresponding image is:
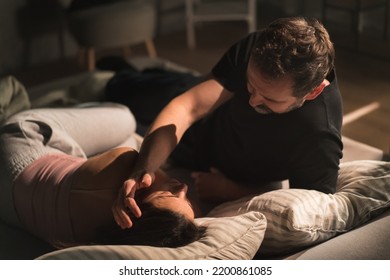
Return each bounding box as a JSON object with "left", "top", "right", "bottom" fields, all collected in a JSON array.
[{"left": 9, "top": 103, "right": 136, "bottom": 157}]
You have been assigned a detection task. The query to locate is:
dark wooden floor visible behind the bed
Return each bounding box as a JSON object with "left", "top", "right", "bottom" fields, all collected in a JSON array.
[{"left": 15, "top": 23, "right": 390, "bottom": 153}]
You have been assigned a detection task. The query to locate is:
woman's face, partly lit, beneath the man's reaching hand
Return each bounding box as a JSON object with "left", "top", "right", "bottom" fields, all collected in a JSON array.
[{"left": 137, "top": 179, "right": 195, "bottom": 220}]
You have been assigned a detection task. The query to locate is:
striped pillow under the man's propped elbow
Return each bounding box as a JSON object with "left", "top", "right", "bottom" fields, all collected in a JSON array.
[{"left": 209, "top": 161, "right": 390, "bottom": 257}]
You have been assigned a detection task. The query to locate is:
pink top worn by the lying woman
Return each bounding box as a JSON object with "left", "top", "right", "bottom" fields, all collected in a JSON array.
[{"left": 14, "top": 154, "right": 86, "bottom": 245}]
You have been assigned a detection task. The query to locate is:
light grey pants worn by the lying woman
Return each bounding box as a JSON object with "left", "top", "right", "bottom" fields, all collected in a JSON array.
[{"left": 0, "top": 103, "right": 136, "bottom": 226}]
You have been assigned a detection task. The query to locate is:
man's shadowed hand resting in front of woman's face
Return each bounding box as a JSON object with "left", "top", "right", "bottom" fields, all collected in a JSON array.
[{"left": 191, "top": 168, "right": 239, "bottom": 202}]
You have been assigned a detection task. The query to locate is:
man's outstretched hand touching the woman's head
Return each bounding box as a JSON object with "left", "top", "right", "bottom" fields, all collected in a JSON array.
[{"left": 112, "top": 173, "right": 153, "bottom": 229}]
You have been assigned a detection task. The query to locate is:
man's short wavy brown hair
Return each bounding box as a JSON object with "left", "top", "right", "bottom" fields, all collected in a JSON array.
[{"left": 251, "top": 17, "right": 335, "bottom": 97}]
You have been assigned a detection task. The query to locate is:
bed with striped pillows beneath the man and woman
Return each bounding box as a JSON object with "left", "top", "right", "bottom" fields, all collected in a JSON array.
[{"left": 0, "top": 57, "right": 390, "bottom": 260}]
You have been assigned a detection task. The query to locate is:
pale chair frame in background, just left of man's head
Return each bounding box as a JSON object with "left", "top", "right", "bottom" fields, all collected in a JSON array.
[{"left": 186, "top": 0, "right": 257, "bottom": 49}]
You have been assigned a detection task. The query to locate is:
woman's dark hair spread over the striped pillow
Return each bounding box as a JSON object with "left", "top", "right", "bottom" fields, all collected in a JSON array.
[{"left": 98, "top": 203, "right": 205, "bottom": 248}]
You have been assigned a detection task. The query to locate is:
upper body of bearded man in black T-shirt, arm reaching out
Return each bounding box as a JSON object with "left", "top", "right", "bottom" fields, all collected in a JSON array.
[{"left": 113, "top": 18, "right": 342, "bottom": 227}]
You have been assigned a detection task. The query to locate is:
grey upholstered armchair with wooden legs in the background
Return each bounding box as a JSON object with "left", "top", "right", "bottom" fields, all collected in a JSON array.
[{"left": 60, "top": 0, "right": 157, "bottom": 70}]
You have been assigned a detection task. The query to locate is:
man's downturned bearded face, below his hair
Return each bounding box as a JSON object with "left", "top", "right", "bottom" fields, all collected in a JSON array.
[{"left": 247, "top": 62, "right": 304, "bottom": 114}]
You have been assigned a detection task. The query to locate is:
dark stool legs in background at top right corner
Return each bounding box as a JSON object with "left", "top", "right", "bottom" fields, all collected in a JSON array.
[{"left": 322, "top": 0, "right": 390, "bottom": 51}]
